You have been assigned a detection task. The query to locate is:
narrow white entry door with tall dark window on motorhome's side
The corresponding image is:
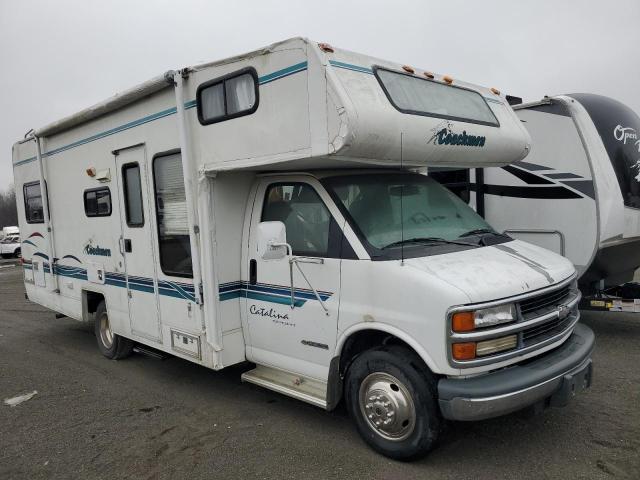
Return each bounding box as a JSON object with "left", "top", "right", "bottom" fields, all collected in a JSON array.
[{"left": 115, "top": 145, "right": 160, "bottom": 341}]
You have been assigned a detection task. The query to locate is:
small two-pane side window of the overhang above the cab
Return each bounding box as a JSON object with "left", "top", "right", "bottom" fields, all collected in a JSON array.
[{"left": 196, "top": 68, "right": 258, "bottom": 125}]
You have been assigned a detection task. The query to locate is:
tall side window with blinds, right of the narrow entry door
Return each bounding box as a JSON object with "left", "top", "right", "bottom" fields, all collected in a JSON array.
[{"left": 153, "top": 152, "right": 193, "bottom": 277}]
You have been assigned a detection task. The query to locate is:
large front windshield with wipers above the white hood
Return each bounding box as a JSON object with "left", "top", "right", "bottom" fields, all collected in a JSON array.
[{"left": 324, "top": 173, "right": 508, "bottom": 256}]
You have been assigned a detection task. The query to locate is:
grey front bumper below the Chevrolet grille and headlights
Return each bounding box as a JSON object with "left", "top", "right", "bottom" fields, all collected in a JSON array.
[{"left": 438, "top": 324, "right": 595, "bottom": 420}]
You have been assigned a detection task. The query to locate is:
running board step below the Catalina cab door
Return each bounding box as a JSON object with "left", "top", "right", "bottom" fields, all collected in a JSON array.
[{"left": 242, "top": 365, "right": 327, "bottom": 410}]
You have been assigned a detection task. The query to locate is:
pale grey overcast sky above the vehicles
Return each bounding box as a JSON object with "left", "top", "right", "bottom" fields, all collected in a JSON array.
[{"left": 0, "top": 0, "right": 640, "bottom": 190}]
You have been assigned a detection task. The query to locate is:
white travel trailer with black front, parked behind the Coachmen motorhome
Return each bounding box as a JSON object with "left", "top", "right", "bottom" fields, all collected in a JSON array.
[{"left": 432, "top": 93, "right": 640, "bottom": 311}]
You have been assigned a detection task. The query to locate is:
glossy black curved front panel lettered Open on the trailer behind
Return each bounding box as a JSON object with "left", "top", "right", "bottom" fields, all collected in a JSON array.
[{"left": 571, "top": 93, "right": 640, "bottom": 208}]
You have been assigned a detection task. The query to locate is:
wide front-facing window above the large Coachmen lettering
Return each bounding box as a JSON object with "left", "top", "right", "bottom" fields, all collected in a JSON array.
[{"left": 374, "top": 68, "right": 499, "bottom": 127}]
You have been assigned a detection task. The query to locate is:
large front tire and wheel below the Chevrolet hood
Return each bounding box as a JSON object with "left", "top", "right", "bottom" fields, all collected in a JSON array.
[{"left": 345, "top": 346, "right": 443, "bottom": 461}]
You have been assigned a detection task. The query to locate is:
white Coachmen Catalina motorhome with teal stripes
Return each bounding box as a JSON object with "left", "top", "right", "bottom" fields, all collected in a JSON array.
[{"left": 13, "top": 38, "right": 594, "bottom": 459}]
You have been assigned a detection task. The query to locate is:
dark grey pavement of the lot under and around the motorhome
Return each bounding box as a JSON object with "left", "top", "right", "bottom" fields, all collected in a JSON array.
[{"left": 0, "top": 267, "right": 640, "bottom": 480}]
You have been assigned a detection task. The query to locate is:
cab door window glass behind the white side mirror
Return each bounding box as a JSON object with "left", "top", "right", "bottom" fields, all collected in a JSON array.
[{"left": 262, "top": 183, "right": 332, "bottom": 257}]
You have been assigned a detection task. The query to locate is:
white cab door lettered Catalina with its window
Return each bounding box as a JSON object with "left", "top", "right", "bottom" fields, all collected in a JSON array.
[{"left": 246, "top": 179, "right": 342, "bottom": 378}]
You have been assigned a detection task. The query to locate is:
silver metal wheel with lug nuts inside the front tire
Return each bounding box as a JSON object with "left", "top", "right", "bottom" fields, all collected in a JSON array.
[{"left": 359, "top": 372, "right": 416, "bottom": 441}]
